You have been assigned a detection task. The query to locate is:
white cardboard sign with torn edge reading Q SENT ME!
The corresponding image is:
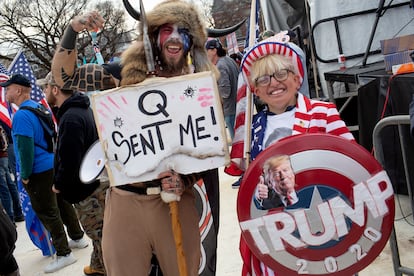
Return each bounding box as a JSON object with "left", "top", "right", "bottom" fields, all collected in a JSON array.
[{"left": 92, "top": 72, "right": 229, "bottom": 186}]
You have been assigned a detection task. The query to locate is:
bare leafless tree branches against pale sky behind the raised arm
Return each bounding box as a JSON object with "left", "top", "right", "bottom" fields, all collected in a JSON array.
[{"left": 0, "top": 0, "right": 126, "bottom": 75}]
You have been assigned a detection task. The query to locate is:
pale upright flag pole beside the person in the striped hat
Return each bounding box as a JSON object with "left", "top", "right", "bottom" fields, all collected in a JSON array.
[{"left": 243, "top": 0, "right": 257, "bottom": 169}]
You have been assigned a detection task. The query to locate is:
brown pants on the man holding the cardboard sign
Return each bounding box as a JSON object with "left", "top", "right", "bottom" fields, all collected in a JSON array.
[{"left": 102, "top": 187, "right": 200, "bottom": 276}]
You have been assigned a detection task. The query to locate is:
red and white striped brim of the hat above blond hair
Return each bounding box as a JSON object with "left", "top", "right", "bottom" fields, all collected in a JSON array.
[{"left": 241, "top": 37, "right": 305, "bottom": 88}]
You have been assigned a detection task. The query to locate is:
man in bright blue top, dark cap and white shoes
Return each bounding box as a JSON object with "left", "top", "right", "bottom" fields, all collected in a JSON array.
[{"left": 0, "top": 74, "right": 76, "bottom": 273}]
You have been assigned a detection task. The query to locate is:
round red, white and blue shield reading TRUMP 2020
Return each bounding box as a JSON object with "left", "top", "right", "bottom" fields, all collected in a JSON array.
[{"left": 237, "top": 134, "right": 394, "bottom": 276}]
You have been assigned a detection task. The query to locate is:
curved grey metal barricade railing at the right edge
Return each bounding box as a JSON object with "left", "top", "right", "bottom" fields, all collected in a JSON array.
[{"left": 372, "top": 115, "right": 414, "bottom": 276}]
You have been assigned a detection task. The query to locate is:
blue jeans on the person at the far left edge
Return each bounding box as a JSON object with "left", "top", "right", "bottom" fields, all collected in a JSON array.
[{"left": 0, "top": 157, "right": 23, "bottom": 221}]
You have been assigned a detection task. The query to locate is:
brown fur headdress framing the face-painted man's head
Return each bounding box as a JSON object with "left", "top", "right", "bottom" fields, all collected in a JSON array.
[{"left": 121, "top": 0, "right": 214, "bottom": 85}]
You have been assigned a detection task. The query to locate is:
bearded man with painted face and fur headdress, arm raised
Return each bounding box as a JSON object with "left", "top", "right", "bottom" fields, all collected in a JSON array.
[{"left": 52, "top": 0, "right": 233, "bottom": 276}]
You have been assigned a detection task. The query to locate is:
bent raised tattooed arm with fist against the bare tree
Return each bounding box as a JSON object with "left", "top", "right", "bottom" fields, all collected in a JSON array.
[{"left": 52, "top": 11, "right": 120, "bottom": 92}]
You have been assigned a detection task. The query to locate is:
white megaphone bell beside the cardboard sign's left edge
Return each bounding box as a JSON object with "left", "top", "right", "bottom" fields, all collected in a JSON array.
[{"left": 79, "top": 140, "right": 106, "bottom": 184}]
